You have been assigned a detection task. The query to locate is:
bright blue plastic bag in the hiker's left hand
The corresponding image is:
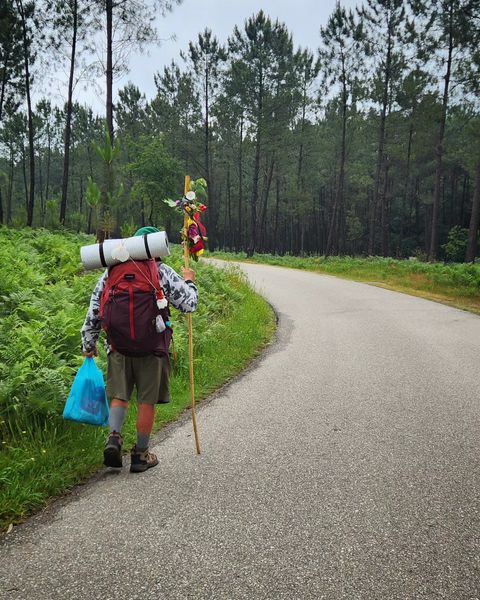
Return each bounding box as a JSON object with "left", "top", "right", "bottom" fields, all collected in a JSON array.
[{"left": 63, "top": 358, "right": 108, "bottom": 425}]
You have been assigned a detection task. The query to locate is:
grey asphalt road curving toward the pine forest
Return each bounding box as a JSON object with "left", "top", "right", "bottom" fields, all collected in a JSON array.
[{"left": 0, "top": 265, "right": 480, "bottom": 600}]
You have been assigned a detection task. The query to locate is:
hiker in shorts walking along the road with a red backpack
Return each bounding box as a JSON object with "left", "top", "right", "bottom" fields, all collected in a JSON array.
[{"left": 81, "top": 227, "right": 198, "bottom": 473}]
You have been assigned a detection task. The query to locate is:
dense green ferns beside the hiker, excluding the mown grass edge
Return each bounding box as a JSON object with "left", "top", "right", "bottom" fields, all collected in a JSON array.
[{"left": 0, "top": 227, "right": 243, "bottom": 443}]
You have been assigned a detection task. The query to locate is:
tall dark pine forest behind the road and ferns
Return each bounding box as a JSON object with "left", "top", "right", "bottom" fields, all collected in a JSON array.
[{"left": 0, "top": 0, "right": 480, "bottom": 262}]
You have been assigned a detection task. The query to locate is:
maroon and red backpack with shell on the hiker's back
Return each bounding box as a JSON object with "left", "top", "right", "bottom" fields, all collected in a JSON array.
[{"left": 100, "top": 259, "right": 172, "bottom": 356}]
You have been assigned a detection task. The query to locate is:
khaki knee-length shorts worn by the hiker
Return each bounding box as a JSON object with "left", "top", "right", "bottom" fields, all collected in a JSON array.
[{"left": 107, "top": 352, "right": 170, "bottom": 404}]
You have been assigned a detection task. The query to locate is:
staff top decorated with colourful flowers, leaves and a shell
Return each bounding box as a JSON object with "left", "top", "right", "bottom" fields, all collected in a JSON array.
[{"left": 164, "top": 179, "right": 207, "bottom": 260}]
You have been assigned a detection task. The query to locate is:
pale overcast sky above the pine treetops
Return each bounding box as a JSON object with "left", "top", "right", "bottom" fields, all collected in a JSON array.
[{"left": 61, "top": 0, "right": 360, "bottom": 112}]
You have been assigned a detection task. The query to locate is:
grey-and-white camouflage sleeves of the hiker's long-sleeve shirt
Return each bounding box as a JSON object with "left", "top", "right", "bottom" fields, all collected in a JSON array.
[{"left": 81, "top": 263, "right": 198, "bottom": 352}]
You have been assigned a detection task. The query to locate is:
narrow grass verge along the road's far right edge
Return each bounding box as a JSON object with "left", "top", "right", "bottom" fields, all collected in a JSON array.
[{"left": 211, "top": 252, "right": 480, "bottom": 314}]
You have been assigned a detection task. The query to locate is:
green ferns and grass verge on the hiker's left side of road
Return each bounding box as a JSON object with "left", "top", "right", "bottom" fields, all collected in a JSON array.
[{"left": 0, "top": 228, "right": 275, "bottom": 530}]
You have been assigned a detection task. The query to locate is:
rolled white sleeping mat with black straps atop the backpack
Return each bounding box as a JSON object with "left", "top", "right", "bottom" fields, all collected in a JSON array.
[{"left": 80, "top": 231, "right": 170, "bottom": 269}]
